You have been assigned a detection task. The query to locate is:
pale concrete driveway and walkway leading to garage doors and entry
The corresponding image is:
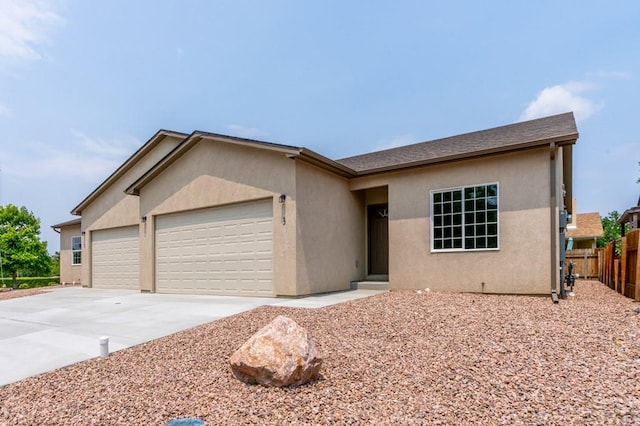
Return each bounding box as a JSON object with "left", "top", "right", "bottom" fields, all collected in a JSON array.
[{"left": 0, "top": 287, "right": 382, "bottom": 386}]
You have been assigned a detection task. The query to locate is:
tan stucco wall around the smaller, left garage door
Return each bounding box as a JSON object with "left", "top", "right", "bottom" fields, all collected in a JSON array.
[{"left": 81, "top": 137, "right": 180, "bottom": 286}]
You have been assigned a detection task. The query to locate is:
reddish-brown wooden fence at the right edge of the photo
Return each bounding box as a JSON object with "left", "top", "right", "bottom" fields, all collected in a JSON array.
[{"left": 600, "top": 229, "right": 640, "bottom": 302}]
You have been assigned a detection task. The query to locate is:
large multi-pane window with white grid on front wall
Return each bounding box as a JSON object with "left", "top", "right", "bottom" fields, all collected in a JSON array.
[{"left": 431, "top": 183, "right": 498, "bottom": 251}]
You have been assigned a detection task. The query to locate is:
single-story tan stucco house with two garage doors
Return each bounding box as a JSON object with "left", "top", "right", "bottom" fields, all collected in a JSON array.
[{"left": 52, "top": 113, "right": 578, "bottom": 296}]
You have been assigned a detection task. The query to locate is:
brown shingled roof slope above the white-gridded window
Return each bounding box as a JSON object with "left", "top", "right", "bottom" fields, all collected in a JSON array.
[{"left": 336, "top": 112, "right": 578, "bottom": 174}]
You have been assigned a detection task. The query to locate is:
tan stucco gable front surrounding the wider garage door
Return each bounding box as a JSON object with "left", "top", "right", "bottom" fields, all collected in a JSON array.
[{"left": 140, "top": 141, "right": 296, "bottom": 295}]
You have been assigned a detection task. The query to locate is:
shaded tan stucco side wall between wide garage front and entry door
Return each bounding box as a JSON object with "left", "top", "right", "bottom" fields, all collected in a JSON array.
[{"left": 296, "top": 161, "right": 365, "bottom": 294}]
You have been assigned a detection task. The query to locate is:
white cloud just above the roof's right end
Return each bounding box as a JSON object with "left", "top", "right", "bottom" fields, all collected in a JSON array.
[{"left": 520, "top": 82, "right": 601, "bottom": 121}]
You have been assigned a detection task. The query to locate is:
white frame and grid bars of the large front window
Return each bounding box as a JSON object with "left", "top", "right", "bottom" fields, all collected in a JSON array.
[{"left": 429, "top": 182, "right": 500, "bottom": 253}]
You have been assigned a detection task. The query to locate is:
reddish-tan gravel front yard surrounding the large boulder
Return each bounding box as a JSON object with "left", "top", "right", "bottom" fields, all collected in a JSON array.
[{"left": 0, "top": 281, "right": 640, "bottom": 425}]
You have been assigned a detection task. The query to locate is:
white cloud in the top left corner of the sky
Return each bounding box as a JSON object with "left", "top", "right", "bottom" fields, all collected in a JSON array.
[{"left": 0, "top": 0, "right": 64, "bottom": 59}]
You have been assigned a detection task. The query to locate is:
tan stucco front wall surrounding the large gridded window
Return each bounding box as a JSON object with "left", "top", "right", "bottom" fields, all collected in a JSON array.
[{"left": 351, "top": 148, "right": 561, "bottom": 294}]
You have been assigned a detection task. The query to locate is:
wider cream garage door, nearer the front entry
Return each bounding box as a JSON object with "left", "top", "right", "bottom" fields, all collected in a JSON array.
[{"left": 156, "top": 200, "right": 273, "bottom": 296}]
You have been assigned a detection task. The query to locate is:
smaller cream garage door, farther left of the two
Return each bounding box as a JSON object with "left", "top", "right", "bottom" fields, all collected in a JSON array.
[{"left": 91, "top": 225, "right": 140, "bottom": 290}]
